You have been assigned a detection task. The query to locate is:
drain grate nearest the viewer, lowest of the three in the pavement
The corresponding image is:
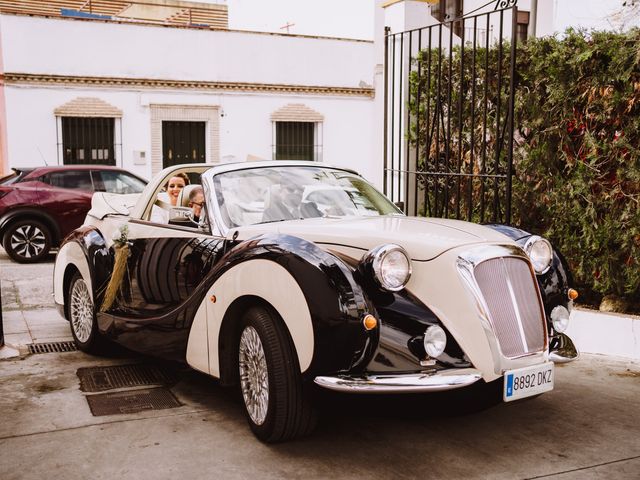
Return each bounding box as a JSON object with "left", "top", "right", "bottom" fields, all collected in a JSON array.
[{"left": 87, "top": 387, "right": 182, "bottom": 417}]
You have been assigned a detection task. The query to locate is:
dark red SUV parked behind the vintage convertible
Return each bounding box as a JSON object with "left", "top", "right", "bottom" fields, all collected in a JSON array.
[{"left": 0, "top": 165, "right": 147, "bottom": 263}]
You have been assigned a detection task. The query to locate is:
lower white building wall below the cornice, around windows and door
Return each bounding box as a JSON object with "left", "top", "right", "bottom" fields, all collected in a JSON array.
[{"left": 5, "top": 86, "right": 381, "bottom": 181}]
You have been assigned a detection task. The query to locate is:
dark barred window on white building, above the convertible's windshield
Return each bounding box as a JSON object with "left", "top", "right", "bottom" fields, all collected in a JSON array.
[{"left": 273, "top": 122, "right": 322, "bottom": 160}]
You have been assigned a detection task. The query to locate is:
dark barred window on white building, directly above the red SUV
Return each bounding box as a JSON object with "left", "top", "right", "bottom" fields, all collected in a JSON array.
[{"left": 62, "top": 117, "right": 116, "bottom": 165}]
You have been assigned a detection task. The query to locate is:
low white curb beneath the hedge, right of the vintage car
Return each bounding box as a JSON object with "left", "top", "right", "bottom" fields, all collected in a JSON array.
[{"left": 565, "top": 307, "right": 640, "bottom": 360}]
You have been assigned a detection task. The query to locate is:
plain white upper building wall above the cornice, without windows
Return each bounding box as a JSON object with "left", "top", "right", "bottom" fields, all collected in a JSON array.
[{"left": 1, "top": 15, "right": 373, "bottom": 87}]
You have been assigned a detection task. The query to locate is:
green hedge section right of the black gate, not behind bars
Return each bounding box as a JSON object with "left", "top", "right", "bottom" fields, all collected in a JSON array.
[{"left": 513, "top": 29, "right": 640, "bottom": 310}]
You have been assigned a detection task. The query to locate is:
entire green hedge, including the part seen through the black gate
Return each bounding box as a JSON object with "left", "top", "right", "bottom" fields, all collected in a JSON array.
[{"left": 408, "top": 29, "right": 640, "bottom": 311}]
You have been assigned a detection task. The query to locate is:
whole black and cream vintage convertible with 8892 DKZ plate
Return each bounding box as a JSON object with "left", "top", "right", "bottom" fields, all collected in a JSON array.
[{"left": 54, "top": 162, "right": 578, "bottom": 442}]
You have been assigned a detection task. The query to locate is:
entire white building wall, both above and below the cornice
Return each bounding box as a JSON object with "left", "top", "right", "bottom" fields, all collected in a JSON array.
[{"left": 0, "top": 15, "right": 382, "bottom": 184}]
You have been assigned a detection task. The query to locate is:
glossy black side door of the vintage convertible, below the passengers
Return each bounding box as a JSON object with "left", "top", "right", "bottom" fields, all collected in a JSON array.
[{"left": 98, "top": 219, "right": 225, "bottom": 360}]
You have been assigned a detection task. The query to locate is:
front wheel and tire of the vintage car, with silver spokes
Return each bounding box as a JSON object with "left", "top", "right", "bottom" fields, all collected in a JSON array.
[{"left": 238, "top": 307, "right": 317, "bottom": 443}]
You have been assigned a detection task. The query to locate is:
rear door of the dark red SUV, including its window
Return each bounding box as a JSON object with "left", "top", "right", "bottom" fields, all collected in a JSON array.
[{"left": 37, "top": 170, "right": 93, "bottom": 238}]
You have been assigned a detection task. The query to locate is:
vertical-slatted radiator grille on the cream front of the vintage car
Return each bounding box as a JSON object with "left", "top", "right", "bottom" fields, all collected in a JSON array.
[{"left": 474, "top": 257, "right": 546, "bottom": 358}]
